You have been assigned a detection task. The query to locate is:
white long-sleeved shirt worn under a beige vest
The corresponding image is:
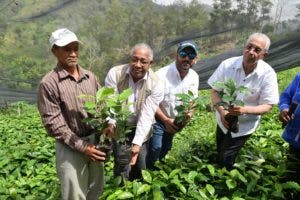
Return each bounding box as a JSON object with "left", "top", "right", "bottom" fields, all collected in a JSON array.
[{"left": 105, "top": 67, "right": 163, "bottom": 146}]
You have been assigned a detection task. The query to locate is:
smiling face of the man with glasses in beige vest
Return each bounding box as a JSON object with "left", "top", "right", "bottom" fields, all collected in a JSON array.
[{"left": 129, "top": 48, "right": 152, "bottom": 82}]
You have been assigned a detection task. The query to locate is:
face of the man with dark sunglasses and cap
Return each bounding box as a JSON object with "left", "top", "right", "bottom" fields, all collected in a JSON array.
[{"left": 176, "top": 47, "right": 197, "bottom": 73}]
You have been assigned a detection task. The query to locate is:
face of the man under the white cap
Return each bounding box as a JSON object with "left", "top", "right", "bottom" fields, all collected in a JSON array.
[{"left": 52, "top": 42, "right": 79, "bottom": 68}]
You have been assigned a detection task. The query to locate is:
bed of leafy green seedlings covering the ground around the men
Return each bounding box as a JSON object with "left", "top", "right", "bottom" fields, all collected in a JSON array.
[{"left": 0, "top": 67, "right": 300, "bottom": 200}]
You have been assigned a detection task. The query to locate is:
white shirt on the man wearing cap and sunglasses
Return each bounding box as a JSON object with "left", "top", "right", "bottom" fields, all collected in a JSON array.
[{"left": 155, "top": 62, "right": 199, "bottom": 119}]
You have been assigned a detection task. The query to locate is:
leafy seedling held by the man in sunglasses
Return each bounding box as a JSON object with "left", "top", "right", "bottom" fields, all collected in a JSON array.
[{"left": 174, "top": 90, "right": 205, "bottom": 130}]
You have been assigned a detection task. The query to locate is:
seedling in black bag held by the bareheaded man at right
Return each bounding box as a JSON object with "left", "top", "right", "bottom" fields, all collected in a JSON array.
[{"left": 213, "top": 78, "right": 249, "bottom": 133}]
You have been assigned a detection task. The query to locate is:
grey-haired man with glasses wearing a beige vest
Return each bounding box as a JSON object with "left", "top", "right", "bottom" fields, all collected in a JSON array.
[{"left": 104, "top": 43, "right": 163, "bottom": 180}]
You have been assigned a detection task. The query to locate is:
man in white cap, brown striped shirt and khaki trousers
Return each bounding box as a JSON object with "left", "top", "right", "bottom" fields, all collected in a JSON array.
[{"left": 38, "top": 28, "right": 105, "bottom": 200}]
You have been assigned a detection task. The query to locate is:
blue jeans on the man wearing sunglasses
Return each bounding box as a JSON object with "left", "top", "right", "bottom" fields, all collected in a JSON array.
[{"left": 147, "top": 120, "right": 174, "bottom": 170}]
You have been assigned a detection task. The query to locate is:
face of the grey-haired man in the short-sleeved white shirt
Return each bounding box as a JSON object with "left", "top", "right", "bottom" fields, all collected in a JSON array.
[{"left": 243, "top": 37, "right": 268, "bottom": 65}]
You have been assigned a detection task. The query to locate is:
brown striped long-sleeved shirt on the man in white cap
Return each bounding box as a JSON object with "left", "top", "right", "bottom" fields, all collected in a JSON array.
[{"left": 38, "top": 67, "right": 99, "bottom": 152}]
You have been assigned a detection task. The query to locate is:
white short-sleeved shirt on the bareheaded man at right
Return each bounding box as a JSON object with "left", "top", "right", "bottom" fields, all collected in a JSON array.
[{"left": 207, "top": 56, "right": 279, "bottom": 137}]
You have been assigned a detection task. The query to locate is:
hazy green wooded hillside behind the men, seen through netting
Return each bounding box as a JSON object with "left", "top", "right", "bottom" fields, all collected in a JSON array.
[{"left": 0, "top": 0, "right": 288, "bottom": 90}]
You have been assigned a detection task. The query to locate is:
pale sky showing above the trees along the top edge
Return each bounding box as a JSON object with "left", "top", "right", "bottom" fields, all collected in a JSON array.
[{"left": 153, "top": 0, "right": 300, "bottom": 20}]
